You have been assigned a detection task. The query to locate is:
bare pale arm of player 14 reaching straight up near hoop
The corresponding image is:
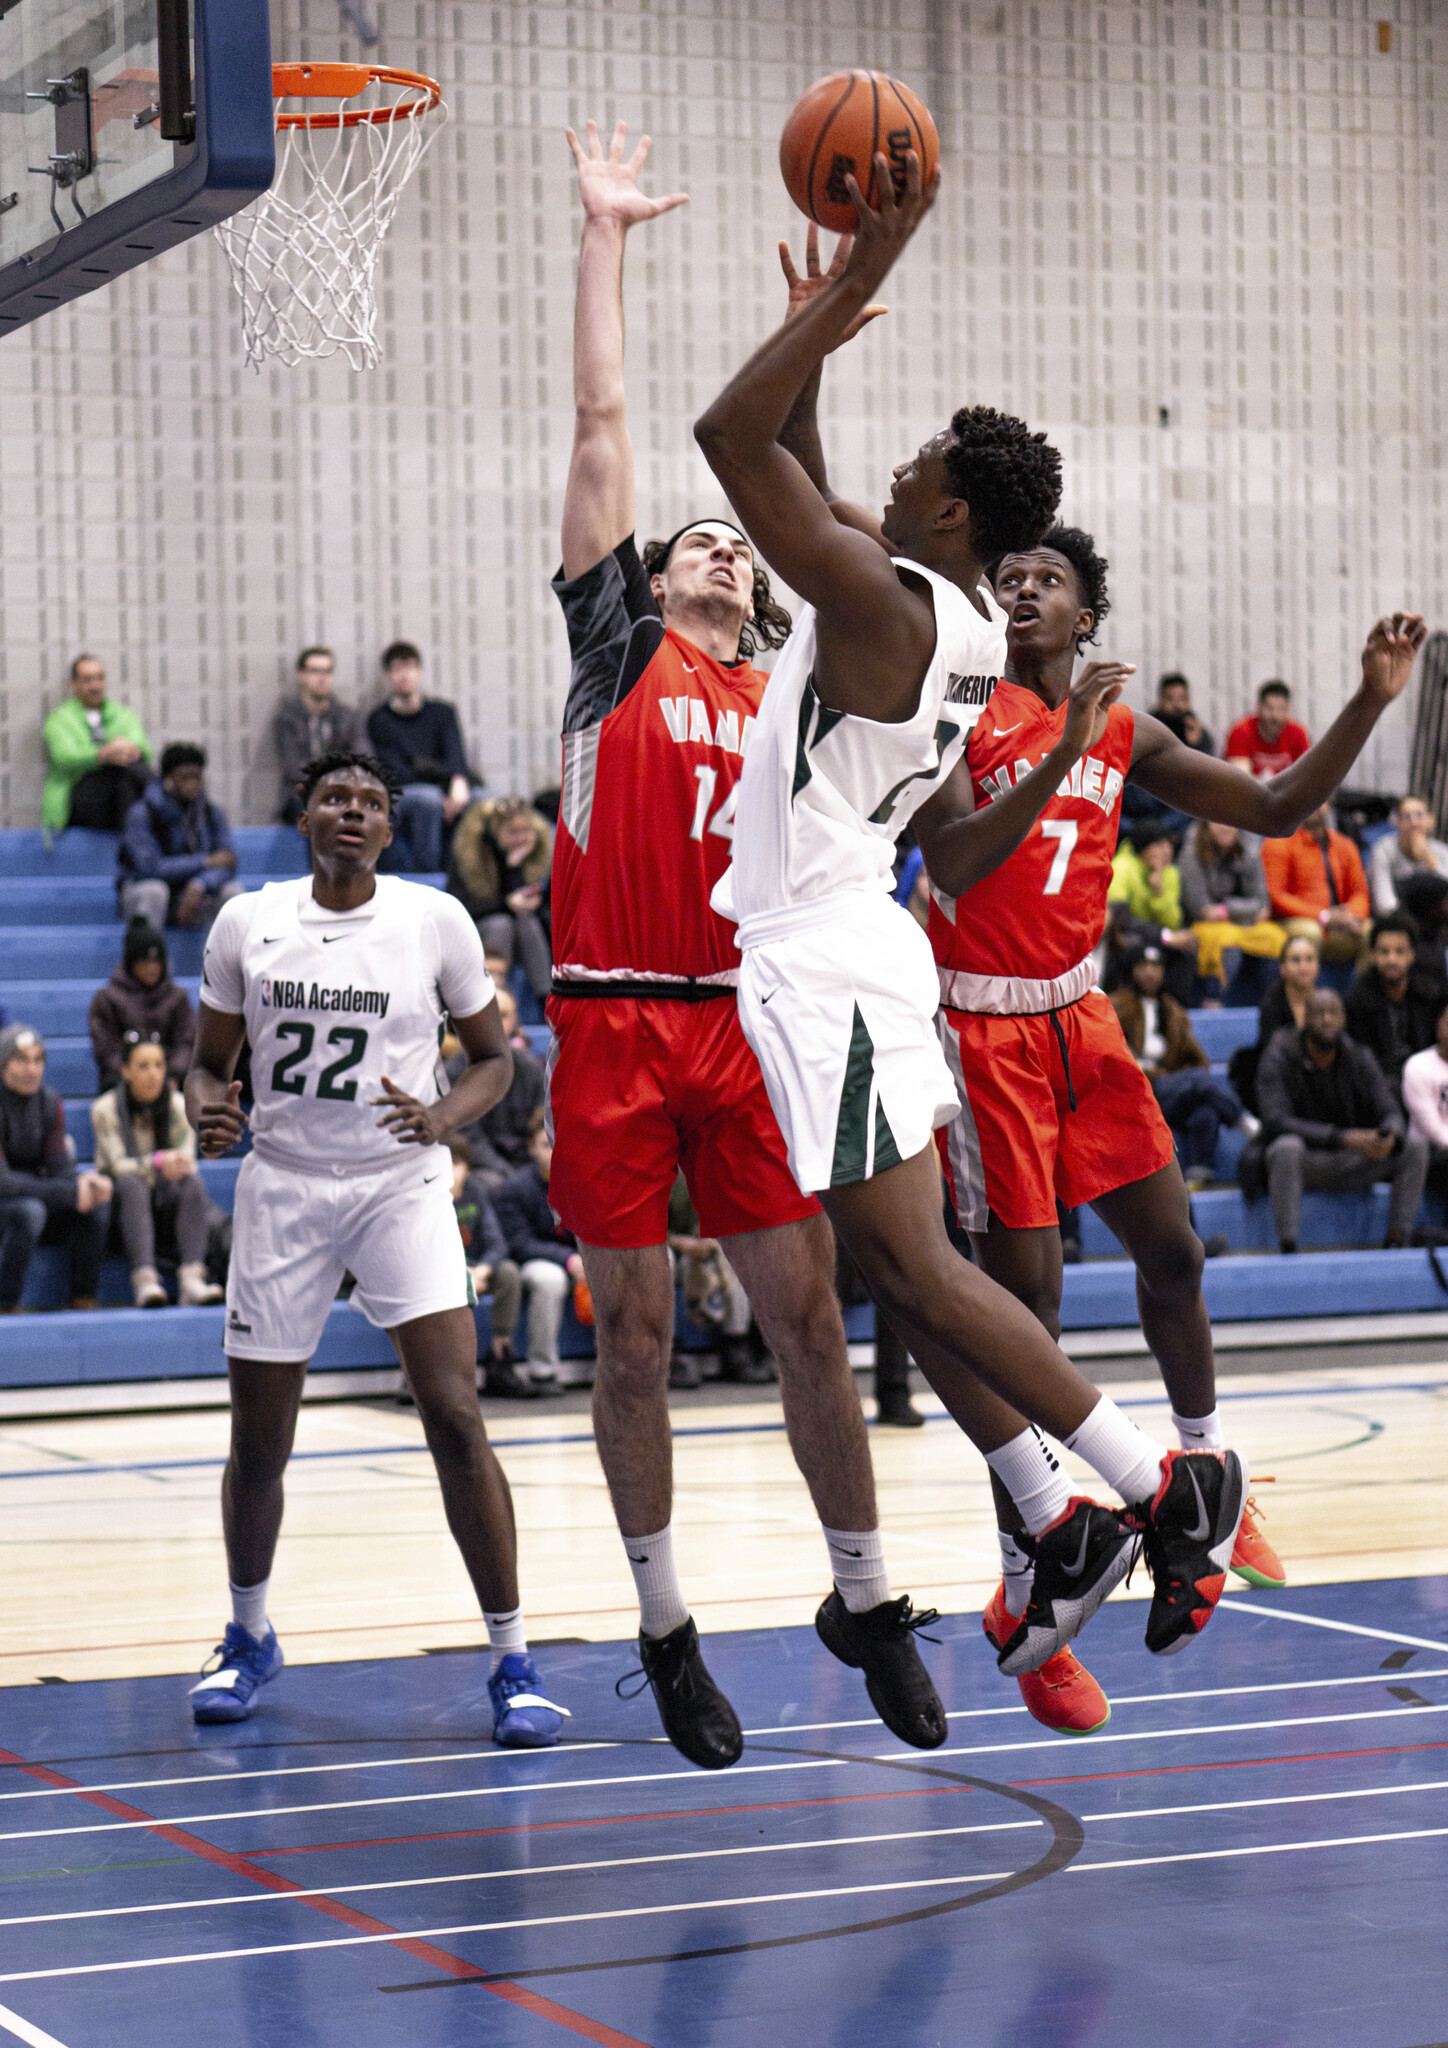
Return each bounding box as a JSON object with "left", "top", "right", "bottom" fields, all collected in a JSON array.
[{"left": 563, "top": 121, "right": 688, "bottom": 582}]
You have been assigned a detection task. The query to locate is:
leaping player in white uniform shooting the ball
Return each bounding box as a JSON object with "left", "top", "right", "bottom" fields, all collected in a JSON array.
[{"left": 694, "top": 154, "right": 1245, "bottom": 1675}]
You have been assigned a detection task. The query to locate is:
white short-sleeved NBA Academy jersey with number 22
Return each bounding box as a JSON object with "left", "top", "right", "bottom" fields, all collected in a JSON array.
[{"left": 201, "top": 874, "right": 494, "bottom": 1174}]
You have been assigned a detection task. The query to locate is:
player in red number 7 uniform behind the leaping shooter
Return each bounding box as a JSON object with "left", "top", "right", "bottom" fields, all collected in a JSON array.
[{"left": 920, "top": 526, "right": 1423, "bottom": 1733}]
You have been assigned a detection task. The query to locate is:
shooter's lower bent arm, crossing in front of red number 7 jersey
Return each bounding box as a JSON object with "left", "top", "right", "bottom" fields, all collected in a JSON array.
[{"left": 915, "top": 662, "right": 1137, "bottom": 897}]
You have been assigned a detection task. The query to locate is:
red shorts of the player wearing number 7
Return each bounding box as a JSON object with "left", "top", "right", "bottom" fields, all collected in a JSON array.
[{"left": 936, "top": 989, "right": 1174, "bottom": 1231}]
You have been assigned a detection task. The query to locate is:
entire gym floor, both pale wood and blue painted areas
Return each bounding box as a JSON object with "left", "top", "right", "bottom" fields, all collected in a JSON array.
[{"left": 0, "top": 1354, "right": 1448, "bottom": 2048}]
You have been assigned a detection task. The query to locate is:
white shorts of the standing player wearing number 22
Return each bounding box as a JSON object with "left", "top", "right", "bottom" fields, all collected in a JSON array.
[{"left": 225, "top": 1145, "right": 473, "bottom": 1362}]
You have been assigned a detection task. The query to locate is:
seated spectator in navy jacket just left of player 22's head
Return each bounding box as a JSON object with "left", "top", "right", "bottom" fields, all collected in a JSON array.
[{"left": 119, "top": 739, "right": 242, "bottom": 926}]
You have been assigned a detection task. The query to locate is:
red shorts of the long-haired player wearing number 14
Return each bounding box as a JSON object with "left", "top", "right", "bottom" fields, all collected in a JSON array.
[{"left": 549, "top": 995, "right": 819, "bottom": 1251}]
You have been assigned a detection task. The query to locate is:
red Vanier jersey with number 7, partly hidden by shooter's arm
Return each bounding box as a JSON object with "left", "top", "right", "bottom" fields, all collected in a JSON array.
[{"left": 930, "top": 682, "right": 1135, "bottom": 1016}]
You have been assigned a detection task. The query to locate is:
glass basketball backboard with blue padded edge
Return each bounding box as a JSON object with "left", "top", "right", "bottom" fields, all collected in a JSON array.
[{"left": 0, "top": 0, "right": 274, "bottom": 334}]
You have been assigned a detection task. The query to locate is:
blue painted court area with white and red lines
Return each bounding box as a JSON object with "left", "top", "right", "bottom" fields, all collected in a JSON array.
[{"left": 0, "top": 1577, "right": 1448, "bottom": 2048}]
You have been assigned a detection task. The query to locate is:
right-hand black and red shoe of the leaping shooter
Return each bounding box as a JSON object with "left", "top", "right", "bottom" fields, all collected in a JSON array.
[{"left": 1131, "top": 1450, "right": 1247, "bottom": 1657}]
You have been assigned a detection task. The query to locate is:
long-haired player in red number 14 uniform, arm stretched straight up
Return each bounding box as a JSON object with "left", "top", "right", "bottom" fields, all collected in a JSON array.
[{"left": 549, "top": 121, "right": 946, "bottom": 1767}]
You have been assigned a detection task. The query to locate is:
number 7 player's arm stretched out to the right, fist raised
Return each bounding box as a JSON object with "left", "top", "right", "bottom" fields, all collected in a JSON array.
[{"left": 1131, "top": 612, "right": 1428, "bottom": 840}]
